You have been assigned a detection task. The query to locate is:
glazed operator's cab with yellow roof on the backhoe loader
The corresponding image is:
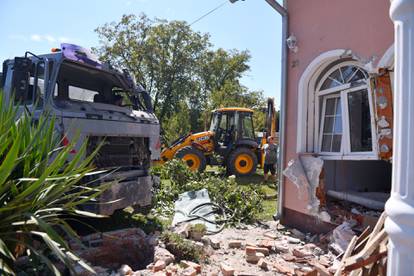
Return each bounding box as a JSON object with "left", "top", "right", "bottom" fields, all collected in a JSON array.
[{"left": 210, "top": 108, "right": 257, "bottom": 156}]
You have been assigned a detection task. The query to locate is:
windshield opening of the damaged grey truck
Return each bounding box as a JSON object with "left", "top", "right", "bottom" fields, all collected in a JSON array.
[{"left": 54, "top": 61, "right": 147, "bottom": 110}]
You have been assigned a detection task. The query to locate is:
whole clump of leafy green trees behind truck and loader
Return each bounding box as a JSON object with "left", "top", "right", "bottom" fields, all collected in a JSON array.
[{"left": 94, "top": 14, "right": 264, "bottom": 141}]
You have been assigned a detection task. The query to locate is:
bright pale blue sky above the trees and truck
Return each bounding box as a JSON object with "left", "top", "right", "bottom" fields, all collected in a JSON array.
[{"left": 0, "top": 0, "right": 282, "bottom": 106}]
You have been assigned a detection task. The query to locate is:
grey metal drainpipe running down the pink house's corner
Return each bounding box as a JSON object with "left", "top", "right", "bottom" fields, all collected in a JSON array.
[{"left": 266, "top": 0, "right": 288, "bottom": 220}]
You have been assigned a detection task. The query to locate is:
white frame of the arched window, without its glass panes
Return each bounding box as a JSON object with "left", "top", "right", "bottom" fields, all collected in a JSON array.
[{"left": 314, "top": 61, "right": 378, "bottom": 160}]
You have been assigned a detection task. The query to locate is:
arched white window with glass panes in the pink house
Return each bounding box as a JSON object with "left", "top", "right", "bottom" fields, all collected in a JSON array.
[{"left": 315, "top": 61, "right": 374, "bottom": 157}]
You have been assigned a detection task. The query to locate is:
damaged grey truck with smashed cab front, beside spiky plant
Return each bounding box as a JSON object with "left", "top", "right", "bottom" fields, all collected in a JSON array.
[{"left": 0, "top": 44, "right": 160, "bottom": 215}]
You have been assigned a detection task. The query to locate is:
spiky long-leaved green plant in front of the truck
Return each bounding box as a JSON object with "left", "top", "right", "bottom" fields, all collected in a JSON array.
[{"left": 0, "top": 94, "right": 109, "bottom": 275}]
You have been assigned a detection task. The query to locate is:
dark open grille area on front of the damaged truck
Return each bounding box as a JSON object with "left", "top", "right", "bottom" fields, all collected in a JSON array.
[{"left": 87, "top": 136, "right": 151, "bottom": 169}]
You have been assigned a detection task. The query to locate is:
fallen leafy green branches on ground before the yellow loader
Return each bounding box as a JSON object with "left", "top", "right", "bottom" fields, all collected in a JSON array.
[{"left": 153, "top": 159, "right": 264, "bottom": 225}]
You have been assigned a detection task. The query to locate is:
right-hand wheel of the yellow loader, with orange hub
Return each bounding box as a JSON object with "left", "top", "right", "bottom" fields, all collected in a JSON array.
[{"left": 227, "top": 148, "right": 257, "bottom": 176}]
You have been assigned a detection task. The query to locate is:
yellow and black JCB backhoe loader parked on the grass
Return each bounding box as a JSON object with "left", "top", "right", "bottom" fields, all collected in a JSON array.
[{"left": 161, "top": 98, "right": 276, "bottom": 176}]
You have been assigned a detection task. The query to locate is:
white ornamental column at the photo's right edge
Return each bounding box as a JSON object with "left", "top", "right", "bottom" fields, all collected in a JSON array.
[{"left": 384, "top": 0, "right": 414, "bottom": 276}]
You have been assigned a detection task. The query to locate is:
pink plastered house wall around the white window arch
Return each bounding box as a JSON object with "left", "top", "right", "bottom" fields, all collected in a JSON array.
[{"left": 283, "top": 0, "right": 394, "bottom": 216}]
